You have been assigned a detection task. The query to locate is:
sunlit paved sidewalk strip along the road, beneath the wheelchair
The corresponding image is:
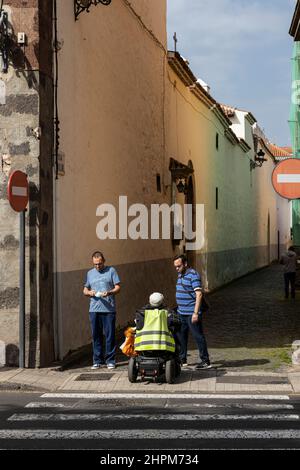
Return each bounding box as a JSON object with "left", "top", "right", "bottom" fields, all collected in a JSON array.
[{"left": 0, "top": 364, "right": 300, "bottom": 394}]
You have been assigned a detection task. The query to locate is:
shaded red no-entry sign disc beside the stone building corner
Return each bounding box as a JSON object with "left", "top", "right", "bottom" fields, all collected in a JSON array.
[{"left": 7, "top": 170, "right": 29, "bottom": 212}]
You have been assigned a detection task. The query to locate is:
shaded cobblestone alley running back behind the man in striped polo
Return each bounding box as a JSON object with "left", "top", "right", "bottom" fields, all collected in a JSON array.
[{"left": 189, "top": 264, "right": 300, "bottom": 369}]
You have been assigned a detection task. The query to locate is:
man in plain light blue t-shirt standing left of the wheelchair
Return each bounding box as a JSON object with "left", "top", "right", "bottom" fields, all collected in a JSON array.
[{"left": 83, "top": 251, "right": 121, "bottom": 369}]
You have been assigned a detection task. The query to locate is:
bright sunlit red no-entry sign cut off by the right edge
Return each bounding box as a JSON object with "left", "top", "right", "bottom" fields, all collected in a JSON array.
[{"left": 272, "top": 158, "right": 300, "bottom": 199}]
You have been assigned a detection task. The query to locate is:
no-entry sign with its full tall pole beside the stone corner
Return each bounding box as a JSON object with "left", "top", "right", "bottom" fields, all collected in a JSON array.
[{"left": 7, "top": 171, "right": 29, "bottom": 368}]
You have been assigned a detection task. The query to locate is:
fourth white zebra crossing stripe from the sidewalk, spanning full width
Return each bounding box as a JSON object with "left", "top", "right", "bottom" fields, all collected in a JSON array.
[{"left": 0, "top": 429, "right": 300, "bottom": 441}]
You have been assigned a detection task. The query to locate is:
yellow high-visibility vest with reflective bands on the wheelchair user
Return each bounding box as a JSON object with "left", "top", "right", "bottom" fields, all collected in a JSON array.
[{"left": 134, "top": 308, "right": 175, "bottom": 352}]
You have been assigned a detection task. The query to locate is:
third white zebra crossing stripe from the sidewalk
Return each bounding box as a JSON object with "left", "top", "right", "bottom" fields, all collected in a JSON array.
[{"left": 8, "top": 413, "right": 299, "bottom": 422}]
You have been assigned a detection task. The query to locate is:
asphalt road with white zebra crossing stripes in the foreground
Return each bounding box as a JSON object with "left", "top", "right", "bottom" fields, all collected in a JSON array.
[{"left": 0, "top": 392, "right": 300, "bottom": 463}]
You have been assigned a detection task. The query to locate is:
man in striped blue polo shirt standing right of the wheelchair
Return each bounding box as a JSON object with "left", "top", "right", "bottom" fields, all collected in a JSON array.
[{"left": 174, "top": 255, "right": 211, "bottom": 369}]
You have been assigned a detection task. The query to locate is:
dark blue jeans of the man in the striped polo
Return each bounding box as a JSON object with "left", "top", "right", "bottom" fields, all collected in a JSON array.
[{"left": 178, "top": 315, "right": 209, "bottom": 363}]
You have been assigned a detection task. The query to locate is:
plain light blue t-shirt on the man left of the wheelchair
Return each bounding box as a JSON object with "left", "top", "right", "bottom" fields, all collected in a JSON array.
[{"left": 84, "top": 266, "right": 120, "bottom": 313}]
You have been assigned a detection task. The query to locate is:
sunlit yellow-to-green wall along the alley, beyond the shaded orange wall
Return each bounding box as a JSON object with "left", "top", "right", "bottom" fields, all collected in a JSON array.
[{"left": 167, "top": 64, "right": 289, "bottom": 289}]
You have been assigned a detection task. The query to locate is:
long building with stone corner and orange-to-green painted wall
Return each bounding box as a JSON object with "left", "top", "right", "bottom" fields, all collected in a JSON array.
[{"left": 0, "top": 0, "right": 289, "bottom": 367}]
